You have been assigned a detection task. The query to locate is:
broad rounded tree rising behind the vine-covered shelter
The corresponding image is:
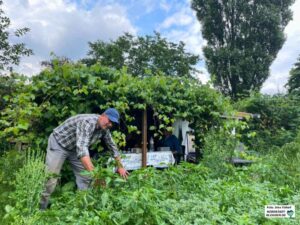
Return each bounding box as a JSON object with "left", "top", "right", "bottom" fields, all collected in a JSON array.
[{"left": 81, "top": 33, "right": 199, "bottom": 77}]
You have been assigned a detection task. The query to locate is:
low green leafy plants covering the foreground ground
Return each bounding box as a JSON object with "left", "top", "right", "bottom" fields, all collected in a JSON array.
[{"left": 4, "top": 148, "right": 300, "bottom": 225}]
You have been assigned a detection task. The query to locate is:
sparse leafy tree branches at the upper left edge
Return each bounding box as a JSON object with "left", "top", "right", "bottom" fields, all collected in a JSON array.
[{"left": 0, "top": 0, "right": 33, "bottom": 72}]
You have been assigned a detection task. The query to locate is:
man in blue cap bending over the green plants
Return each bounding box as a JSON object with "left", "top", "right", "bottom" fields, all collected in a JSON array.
[{"left": 40, "top": 108, "right": 129, "bottom": 209}]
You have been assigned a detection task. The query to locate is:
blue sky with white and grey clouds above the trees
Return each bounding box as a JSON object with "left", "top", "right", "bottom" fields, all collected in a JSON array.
[{"left": 3, "top": 0, "right": 300, "bottom": 94}]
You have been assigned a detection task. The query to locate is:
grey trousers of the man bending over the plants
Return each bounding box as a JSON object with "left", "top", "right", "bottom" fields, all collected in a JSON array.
[{"left": 40, "top": 134, "right": 92, "bottom": 209}]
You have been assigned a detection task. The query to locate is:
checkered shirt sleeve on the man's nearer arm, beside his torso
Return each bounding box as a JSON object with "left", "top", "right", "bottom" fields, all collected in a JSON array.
[{"left": 76, "top": 120, "right": 94, "bottom": 158}]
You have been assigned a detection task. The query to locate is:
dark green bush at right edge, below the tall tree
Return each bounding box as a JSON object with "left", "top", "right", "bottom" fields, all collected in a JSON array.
[{"left": 235, "top": 94, "right": 300, "bottom": 152}]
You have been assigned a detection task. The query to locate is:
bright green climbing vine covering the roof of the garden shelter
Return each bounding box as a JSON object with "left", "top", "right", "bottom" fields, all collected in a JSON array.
[{"left": 0, "top": 62, "right": 232, "bottom": 154}]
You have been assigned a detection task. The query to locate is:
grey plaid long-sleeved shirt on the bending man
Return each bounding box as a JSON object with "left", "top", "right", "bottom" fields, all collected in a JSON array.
[{"left": 53, "top": 114, "right": 120, "bottom": 158}]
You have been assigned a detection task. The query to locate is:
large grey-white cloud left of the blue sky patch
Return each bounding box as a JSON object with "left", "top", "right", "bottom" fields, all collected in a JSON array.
[{"left": 4, "top": 0, "right": 136, "bottom": 74}]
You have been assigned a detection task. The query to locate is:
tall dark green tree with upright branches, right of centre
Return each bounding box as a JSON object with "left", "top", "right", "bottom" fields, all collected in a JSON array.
[{"left": 192, "top": 0, "right": 294, "bottom": 99}]
